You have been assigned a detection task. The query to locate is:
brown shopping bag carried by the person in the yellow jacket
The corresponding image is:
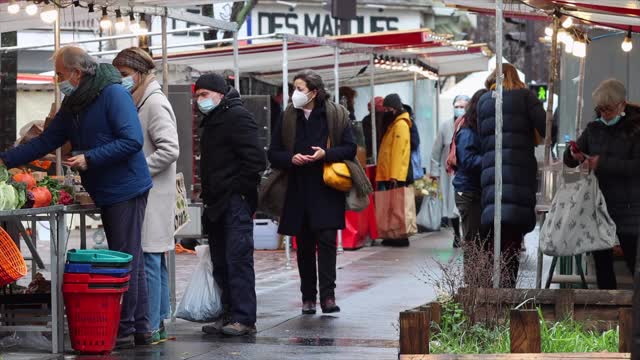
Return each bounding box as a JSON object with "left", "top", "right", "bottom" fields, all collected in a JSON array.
[{"left": 375, "top": 186, "right": 418, "bottom": 239}]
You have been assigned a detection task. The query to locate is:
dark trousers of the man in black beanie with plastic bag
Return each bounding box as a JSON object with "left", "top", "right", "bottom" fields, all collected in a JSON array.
[{"left": 203, "top": 194, "right": 257, "bottom": 326}]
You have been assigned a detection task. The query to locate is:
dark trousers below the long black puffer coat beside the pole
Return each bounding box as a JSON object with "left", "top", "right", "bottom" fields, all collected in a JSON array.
[{"left": 480, "top": 224, "right": 525, "bottom": 288}]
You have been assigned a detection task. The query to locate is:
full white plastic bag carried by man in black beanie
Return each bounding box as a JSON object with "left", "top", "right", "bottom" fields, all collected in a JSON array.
[{"left": 176, "top": 245, "right": 222, "bottom": 322}]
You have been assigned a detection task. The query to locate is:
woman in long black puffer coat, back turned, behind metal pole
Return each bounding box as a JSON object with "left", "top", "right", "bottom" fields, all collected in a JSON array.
[{"left": 478, "top": 64, "right": 545, "bottom": 288}]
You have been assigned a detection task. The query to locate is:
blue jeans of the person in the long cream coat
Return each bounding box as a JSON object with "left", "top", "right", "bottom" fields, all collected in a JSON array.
[{"left": 144, "top": 253, "right": 170, "bottom": 331}]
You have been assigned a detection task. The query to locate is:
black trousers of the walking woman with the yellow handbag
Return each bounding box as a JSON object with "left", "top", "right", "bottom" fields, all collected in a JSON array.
[{"left": 296, "top": 217, "right": 337, "bottom": 302}]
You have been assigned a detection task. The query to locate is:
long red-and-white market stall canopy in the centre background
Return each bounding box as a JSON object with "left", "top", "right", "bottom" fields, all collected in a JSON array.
[{"left": 160, "top": 29, "right": 488, "bottom": 86}]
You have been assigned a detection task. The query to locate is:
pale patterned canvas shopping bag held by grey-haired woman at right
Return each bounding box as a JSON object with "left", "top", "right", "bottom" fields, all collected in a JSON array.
[{"left": 540, "top": 174, "right": 618, "bottom": 256}]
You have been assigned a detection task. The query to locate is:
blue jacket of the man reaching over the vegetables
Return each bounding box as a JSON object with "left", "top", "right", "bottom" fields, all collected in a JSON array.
[{"left": 0, "top": 84, "right": 152, "bottom": 206}]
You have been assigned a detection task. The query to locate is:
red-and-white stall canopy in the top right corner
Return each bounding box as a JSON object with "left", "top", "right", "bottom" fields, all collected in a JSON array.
[{"left": 444, "top": 0, "right": 640, "bottom": 32}]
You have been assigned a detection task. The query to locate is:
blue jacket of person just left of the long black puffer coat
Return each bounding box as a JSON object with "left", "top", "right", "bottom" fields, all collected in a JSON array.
[{"left": 453, "top": 127, "right": 482, "bottom": 192}]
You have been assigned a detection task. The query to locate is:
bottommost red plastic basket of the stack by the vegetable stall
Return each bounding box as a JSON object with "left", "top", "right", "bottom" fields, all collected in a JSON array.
[{"left": 62, "top": 283, "right": 129, "bottom": 354}]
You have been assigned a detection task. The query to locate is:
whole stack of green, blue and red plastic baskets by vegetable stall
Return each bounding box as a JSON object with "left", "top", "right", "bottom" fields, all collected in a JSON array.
[{"left": 62, "top": 250, "right": 133, "bottom": 354}]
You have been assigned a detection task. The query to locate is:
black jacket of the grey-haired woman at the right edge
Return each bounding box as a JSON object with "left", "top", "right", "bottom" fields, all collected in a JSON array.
[{"left": 564, "top": 105, "right": 640, "bottom": 235}]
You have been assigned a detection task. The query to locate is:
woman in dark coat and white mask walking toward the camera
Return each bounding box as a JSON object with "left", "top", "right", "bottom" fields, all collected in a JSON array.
[{"left": 268, "top": 70, "right": 357, "bottom": 314}]
